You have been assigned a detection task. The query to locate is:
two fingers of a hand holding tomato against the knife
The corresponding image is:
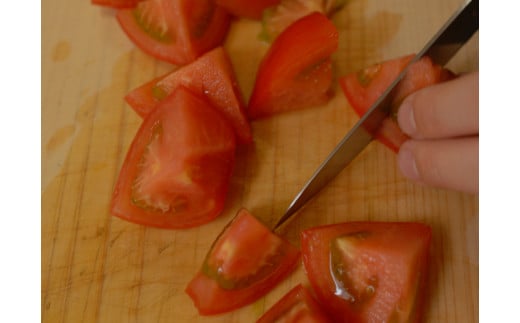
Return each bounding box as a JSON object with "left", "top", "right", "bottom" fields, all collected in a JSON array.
[{"left": 397, "top": 72, "right": 479, "bottom": 193}]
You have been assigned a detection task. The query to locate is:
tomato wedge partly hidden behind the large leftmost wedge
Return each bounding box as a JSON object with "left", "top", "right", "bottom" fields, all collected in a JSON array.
[{"left": 125, "top": 46, "right": 253, "bottom": 143}]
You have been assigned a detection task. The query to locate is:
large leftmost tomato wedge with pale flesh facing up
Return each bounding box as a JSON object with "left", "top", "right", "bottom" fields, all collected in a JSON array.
[{"left": 111, "top": 87, "right": 236, "bottom": 229}]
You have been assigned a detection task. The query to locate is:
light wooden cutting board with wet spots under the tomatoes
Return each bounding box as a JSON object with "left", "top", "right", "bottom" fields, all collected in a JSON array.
[{"left": 41, "top": 0, "right": 479, "bottom": 323}]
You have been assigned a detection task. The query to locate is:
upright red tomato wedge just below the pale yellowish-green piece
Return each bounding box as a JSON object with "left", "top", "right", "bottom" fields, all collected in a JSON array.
[{"left": 248, "top": 12, "right": 338, "bottom": 118}]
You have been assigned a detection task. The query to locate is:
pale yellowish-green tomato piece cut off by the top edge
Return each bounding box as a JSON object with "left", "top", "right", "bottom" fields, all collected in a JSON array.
[{"left": 261, "top": 0, "right": 346, "bottom": 42}]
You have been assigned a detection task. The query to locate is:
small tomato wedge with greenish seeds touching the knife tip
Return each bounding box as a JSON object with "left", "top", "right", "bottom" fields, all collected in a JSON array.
[{"left": 186, "top": 209, "right": 300, "bottom": 315}]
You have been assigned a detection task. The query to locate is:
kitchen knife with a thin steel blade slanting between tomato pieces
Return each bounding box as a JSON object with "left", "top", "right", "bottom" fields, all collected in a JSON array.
[{"left": 273, "top": 0, "right": 478, "bottom": 231}]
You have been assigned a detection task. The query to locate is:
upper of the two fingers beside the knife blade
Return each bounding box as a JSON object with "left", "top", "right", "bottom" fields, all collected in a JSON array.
[{"left": 397, "top": 72, "right": 478, "bottom": 139}]
